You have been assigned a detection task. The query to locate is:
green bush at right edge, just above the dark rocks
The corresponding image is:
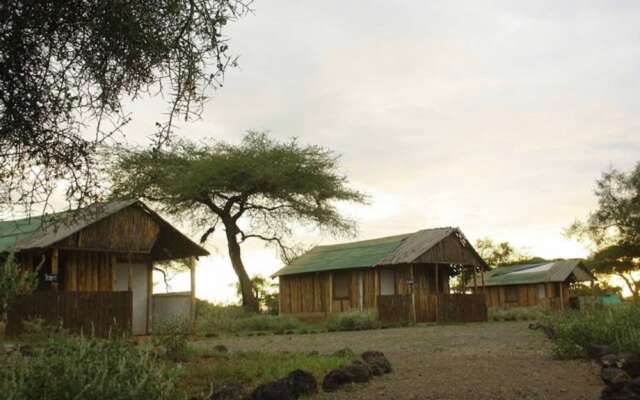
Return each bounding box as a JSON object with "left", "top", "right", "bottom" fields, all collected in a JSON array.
[{"left": 547, "top": 304, "right": 640, "bottom": 358}]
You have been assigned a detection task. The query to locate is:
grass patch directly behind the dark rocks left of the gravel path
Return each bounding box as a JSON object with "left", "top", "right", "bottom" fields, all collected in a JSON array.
[{"left": 180, "top": 352, "right": 352, "bottom": 397}]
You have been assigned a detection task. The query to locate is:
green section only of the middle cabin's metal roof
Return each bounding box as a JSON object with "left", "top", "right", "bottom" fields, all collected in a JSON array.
[{"left": 274, "top": 233, "right": 414, "bottom": 276}]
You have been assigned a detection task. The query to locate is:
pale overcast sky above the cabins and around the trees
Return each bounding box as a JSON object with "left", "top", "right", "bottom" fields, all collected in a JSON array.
[{"left": 127, "top": 0, "right": 640, "bottom": 301}]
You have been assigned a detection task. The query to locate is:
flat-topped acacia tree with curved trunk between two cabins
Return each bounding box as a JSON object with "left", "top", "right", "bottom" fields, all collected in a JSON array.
[{"left": 111, "top": 132, "right": 365, "bottom": 311}]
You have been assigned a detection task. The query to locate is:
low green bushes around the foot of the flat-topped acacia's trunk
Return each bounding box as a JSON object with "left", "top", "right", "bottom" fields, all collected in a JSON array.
[{"left": 196, "top": 300, "right": 303, "bottom": 336}]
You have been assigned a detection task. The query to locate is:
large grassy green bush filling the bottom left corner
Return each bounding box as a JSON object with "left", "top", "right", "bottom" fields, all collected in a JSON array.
[{"left": 0, "top": 337, "right": 183, "bottom": 400}]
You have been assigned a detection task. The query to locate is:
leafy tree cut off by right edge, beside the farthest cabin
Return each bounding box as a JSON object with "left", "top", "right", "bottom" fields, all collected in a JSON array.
[{"left": 568, "top": 163, "right": 640, "bottom": 300}]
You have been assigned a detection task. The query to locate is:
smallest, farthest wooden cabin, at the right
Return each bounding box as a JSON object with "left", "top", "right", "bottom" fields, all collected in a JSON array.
[{"left": 478, "top": 260, "right": 595, "bottom": 309}]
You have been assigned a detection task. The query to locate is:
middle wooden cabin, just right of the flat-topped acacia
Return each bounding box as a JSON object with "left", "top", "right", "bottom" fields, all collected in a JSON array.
[{"left": 274, "top": 227, "right": 488, "bottom": 322}]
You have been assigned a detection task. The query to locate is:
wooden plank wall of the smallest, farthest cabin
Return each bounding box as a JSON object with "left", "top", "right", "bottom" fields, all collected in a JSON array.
[{"left": 485, "top": 282, "right": 569, "bottom": 309}]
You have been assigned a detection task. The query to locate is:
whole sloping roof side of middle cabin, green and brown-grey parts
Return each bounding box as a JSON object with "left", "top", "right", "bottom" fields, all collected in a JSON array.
[{"left": 273, "top": 227, "right": 482, "bottom": 276}]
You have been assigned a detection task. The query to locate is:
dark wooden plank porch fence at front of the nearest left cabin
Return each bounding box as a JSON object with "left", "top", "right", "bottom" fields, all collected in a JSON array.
[{"left": 6, "top": 292, "right": 132, "bottom": 337}]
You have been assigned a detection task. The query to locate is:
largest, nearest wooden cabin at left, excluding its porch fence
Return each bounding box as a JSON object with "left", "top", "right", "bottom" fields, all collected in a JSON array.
[{"left": 0, "top": 200, "right": 209, "bottom": 334}]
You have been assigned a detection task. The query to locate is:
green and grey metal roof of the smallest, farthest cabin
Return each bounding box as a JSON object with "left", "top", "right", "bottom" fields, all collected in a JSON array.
[{"left": 478, "top": 259, "right": 595, "bottom": 286}]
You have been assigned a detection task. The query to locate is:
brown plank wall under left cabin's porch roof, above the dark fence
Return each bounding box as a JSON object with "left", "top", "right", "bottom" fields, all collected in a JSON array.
[{"left": 59, "top": 251, "right": 113, "bottom": 292}]
